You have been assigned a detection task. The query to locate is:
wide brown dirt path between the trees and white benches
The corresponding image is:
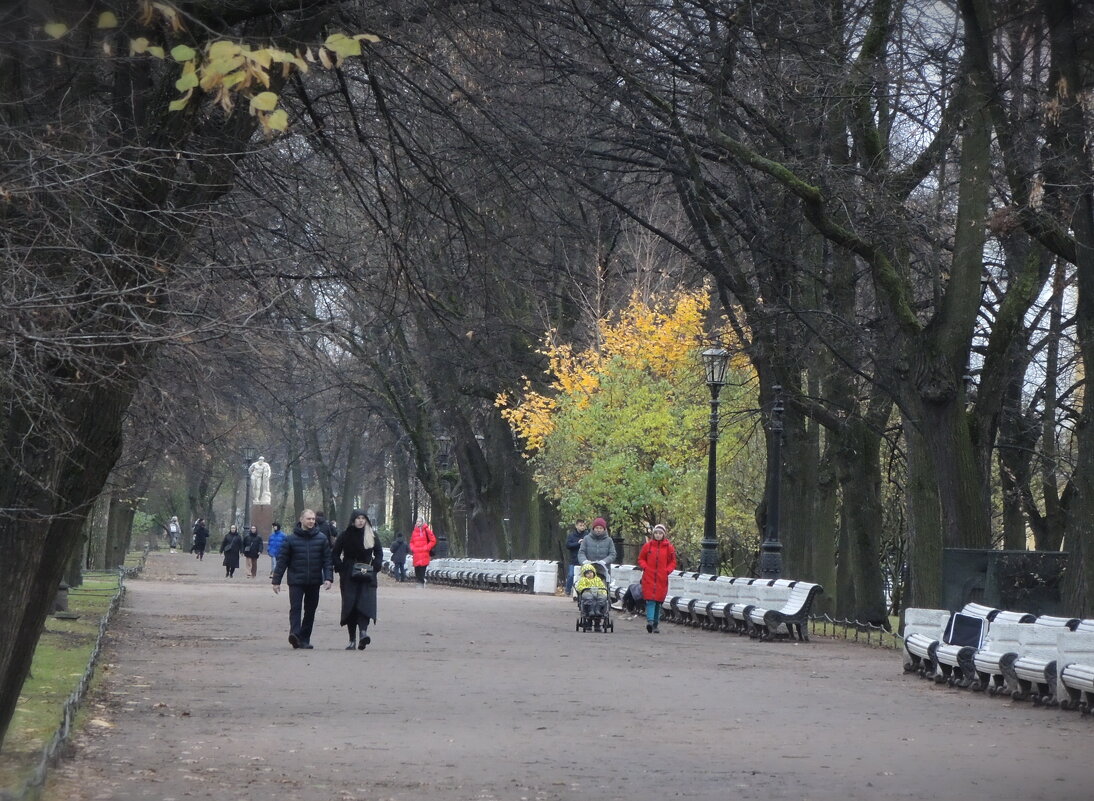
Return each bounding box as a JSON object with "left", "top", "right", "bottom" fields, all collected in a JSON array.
[{"left": 45, "top": 554, "right": 1094, "bottom": 801}]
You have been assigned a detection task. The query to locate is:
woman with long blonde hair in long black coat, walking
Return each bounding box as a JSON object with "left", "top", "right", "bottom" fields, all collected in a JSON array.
[{"left": 334, "top": 510, "right": 384, "bottom": 651}]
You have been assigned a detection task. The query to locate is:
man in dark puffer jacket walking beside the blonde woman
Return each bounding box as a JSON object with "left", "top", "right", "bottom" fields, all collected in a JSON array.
[{"left": 271, "top": 509, "right": 334, "bottom": 648}]
